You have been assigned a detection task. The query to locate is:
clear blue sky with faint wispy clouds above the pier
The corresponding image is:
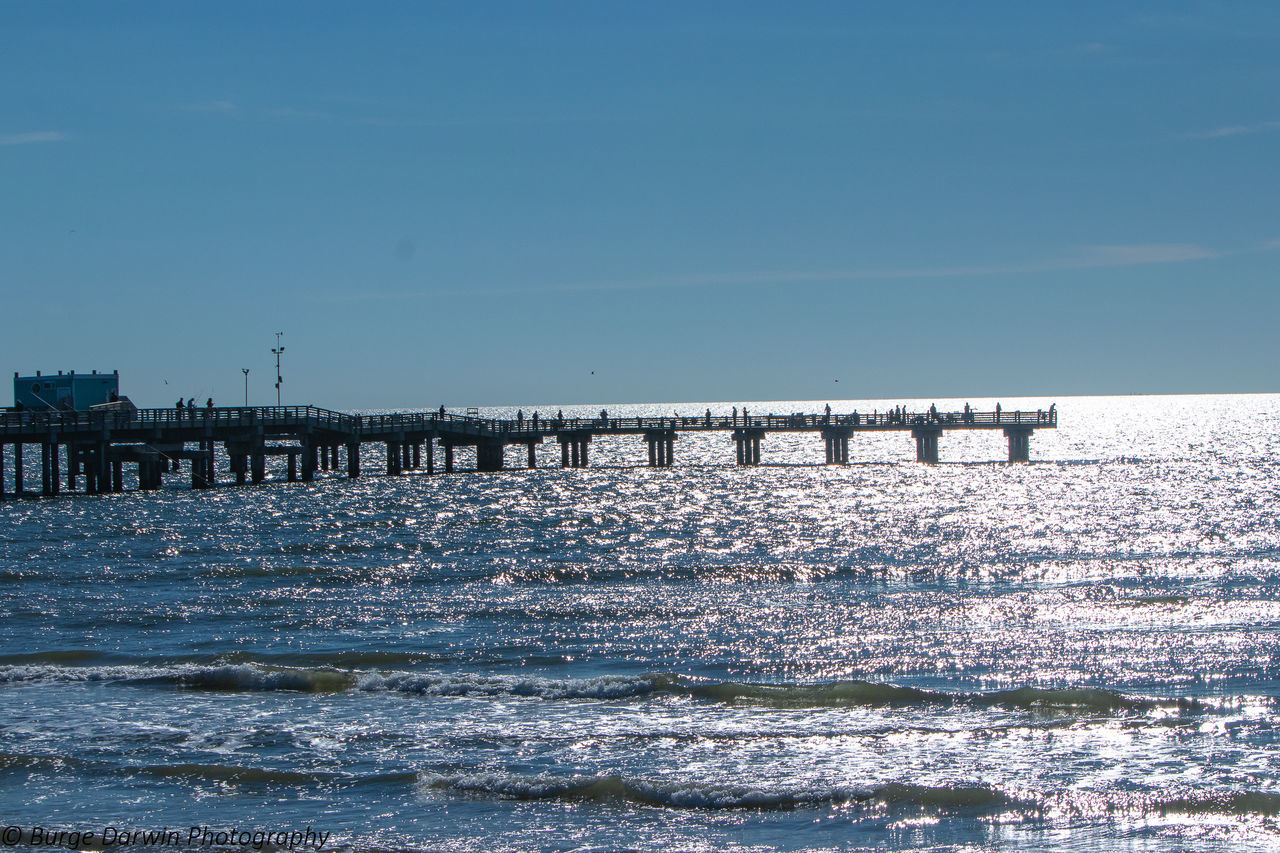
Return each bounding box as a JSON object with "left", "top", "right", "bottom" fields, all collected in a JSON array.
[{"left": 0, "top": 0, "right": 1280, "bottom": 410}]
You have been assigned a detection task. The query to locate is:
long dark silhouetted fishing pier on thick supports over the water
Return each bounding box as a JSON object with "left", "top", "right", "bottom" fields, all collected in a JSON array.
[{"left": 0, "top": 406, "right": 1057, "bottom": 500}]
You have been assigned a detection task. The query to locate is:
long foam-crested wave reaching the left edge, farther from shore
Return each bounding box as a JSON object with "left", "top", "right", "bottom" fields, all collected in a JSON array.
[{"left": 0, "top": 662, "right": 1213, "bottom": 713}]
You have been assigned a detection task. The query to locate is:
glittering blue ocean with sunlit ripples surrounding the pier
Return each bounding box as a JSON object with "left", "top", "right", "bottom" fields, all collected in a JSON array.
[{"left": 0, "top": 394, "right": 1280, "bottom": 852}]
